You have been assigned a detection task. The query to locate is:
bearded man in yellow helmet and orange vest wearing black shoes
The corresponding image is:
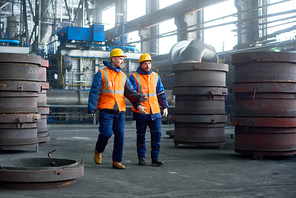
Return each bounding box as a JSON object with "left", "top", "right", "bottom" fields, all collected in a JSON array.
[{"left": 130, "top": 53, "right": 168, "bottom": 166}]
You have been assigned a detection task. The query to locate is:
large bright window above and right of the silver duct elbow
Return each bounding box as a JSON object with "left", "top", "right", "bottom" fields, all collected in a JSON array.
[{"left": 204, "top": 0, "right": 237, "bottom": 52}]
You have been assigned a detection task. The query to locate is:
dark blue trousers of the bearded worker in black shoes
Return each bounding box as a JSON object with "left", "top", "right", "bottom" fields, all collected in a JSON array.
[{"left": 136, "top": 119, "right": 161, "bottom": 159}]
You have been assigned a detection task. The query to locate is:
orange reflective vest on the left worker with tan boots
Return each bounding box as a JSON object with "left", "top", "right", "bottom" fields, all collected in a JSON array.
[{"left": 98, "top": 67, "right": 126, "bottom": 111}]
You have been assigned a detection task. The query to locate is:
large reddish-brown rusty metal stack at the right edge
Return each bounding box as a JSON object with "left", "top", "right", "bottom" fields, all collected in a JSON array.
[{"left": 231, "top": 52, "right": 296, "bottom": 159}]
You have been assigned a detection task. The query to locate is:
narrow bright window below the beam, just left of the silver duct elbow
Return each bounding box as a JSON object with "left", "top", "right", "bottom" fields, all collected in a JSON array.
[{"left": 159, "top": 19, "right": 177, "bottom": 54}]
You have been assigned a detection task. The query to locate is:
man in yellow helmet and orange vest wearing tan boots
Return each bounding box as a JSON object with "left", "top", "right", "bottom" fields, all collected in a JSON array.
[{"left": 88, "top": 48, "right": 147, "bottom": 169}]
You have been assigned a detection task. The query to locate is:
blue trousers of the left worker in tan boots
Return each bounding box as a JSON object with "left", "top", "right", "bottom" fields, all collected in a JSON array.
[{"left": 96, "top": 110, "right": 125, "bottom": 162}]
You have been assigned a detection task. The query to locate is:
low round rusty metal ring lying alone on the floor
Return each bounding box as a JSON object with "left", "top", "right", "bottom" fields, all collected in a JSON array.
[{"left": 0, "top": 158, "right": 84, "bottom": 184}]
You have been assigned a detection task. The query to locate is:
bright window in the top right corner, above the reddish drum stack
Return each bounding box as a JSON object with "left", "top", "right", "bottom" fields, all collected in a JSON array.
[{"left": 267, "top": 0, "right": 296, "bottom": 42}]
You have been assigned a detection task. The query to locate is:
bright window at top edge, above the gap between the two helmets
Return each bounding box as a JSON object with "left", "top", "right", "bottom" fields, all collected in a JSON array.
[{"left": 126, "top": 0, "right": 146, "bottom": 21}]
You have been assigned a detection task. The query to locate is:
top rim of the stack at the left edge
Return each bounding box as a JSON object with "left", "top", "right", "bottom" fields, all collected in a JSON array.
[{"left": 0, "top": 53, "right": 41, "bottom": 65}]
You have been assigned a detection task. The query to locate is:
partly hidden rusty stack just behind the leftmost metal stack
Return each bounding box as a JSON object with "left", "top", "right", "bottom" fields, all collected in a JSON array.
[{"left": 37, "top": 60, "right": 50, "bottom": 143}]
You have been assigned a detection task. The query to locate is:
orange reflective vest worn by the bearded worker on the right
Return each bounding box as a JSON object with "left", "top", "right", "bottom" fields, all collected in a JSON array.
[{"left": 132, "top": 72, "right": 160, "bottom": 114}]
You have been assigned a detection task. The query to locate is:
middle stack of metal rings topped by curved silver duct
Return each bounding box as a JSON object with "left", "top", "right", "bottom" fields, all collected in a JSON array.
[{"left": 172, "top": 40, "right": 228, "bottom": 148}]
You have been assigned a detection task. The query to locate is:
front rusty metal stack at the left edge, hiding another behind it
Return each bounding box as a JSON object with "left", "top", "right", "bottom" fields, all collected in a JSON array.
[{"left": 0, "top": 53, "right": 41, "bottom": 149}]
